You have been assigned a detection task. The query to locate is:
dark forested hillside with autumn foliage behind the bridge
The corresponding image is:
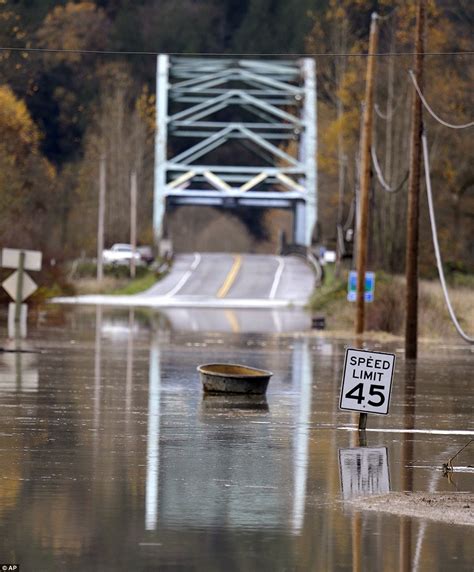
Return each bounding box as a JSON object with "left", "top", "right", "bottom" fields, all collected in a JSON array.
[{"left": 0, "top": 0, "right": 474, "bottom": 274}]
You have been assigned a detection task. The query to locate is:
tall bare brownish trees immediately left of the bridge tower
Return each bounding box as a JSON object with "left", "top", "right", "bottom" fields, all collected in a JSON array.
[{"left": 71, "top": 63, "right": 155, "bottom": 252}]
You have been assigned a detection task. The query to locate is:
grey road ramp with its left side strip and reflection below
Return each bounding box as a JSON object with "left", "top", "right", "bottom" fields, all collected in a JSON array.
[{"left": 53, "top": 252, "right": 314, "bottom": 312}]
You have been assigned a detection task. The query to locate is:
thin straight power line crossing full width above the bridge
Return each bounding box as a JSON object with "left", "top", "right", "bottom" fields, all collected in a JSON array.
[{"left": 0, "top": 46, "right": 474, "bottom": 58}]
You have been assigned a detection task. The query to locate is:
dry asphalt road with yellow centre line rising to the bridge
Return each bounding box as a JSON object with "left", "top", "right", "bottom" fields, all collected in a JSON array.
[{"left": 140, "top": 253, "right": 314, "bottom": 303}]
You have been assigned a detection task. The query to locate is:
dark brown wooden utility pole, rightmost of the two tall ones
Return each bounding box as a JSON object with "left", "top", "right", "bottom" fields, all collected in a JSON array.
[{"left": 405, "top": 0, "right": 425, "bottom": 358}]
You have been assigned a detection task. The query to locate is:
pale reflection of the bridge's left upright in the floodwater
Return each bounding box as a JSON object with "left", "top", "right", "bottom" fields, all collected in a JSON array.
[{"left": 145, "top": 337, "right": 161, "bottom": 530}]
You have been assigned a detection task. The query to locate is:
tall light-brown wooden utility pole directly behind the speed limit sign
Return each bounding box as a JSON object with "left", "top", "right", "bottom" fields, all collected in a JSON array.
[{"left": 356, "top": 12, "right": 378, "bottom": 334}]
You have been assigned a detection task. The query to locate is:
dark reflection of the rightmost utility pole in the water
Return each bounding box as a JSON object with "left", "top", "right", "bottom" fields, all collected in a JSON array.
[{"left": 400, "top": 361, "right": 416, "bottom": 572}]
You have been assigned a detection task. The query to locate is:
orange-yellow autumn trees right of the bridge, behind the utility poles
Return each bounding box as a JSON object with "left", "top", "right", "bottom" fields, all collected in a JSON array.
[{"left": 307, "top": 0, "right": 472, "bottom": 271}]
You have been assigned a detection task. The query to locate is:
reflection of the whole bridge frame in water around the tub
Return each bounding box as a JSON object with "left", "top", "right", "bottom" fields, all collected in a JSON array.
[{"left": 141, "top": 335, "right": 312, "bottom": 533}]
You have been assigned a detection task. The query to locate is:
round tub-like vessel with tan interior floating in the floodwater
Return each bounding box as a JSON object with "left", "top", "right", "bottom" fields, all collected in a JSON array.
[{"left": 197, "top": 363, "right": 273, "bottom": 395}]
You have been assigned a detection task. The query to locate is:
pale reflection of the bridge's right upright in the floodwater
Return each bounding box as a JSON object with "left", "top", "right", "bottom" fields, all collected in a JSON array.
[{"left": 292, "top": 340, "right": 313, "bottom": 533}]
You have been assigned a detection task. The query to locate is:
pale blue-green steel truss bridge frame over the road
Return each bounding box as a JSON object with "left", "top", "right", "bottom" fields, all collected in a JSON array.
[{"left": 153, "top": 55, "right": 317, "bottom": 246}]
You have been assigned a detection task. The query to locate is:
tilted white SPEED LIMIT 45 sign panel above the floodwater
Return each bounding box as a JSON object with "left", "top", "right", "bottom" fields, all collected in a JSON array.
[{"left": 339, "top": 348, "right": 395, "bottom": 415}]
